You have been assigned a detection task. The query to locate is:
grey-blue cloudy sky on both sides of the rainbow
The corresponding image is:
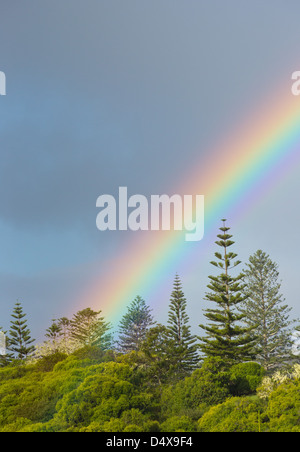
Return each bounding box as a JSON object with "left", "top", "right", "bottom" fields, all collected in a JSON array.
[{"left": 0, "top": 0, "right": 300, "bottom": 338}]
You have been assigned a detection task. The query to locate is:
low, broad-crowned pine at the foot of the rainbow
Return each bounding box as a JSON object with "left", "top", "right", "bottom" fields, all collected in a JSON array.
[{"left": 70, "top": 308, "right": 112, "bottom": 350}]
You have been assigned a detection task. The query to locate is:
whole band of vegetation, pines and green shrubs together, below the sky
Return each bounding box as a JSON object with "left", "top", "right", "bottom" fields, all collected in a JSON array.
[{"left": 0, "top": 220, "right": 300, "bottom": 432}]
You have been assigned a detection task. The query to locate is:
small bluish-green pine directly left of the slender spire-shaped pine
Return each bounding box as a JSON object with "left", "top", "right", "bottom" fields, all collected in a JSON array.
[{"left": 118, "top": 296, "right": 154, "bottom": 353}]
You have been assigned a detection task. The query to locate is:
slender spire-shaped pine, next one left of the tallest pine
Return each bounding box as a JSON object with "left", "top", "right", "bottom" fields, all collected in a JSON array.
[{"left": 166, "top": 275, "right": 199, "bottom": 378}]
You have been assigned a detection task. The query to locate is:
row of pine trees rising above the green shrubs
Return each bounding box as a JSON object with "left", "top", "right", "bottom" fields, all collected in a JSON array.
[{"left": 2, "top": 220, "right": 300, "bottom": 370}]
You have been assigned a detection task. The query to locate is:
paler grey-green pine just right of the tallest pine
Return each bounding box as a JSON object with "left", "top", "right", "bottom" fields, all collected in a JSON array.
[{"left": 242, "top": 250, "right": 292, "bottom": 371}]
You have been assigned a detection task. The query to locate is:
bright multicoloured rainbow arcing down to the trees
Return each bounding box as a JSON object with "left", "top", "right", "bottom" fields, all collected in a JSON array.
[{"left": 74, "top": 82, "right": 300, "bottom": 322}]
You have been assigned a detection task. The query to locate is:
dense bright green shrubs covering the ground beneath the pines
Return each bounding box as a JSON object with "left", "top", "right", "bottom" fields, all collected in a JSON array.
[{"left": 0, "top": 352, "right": 300, "bottom": 432}]
